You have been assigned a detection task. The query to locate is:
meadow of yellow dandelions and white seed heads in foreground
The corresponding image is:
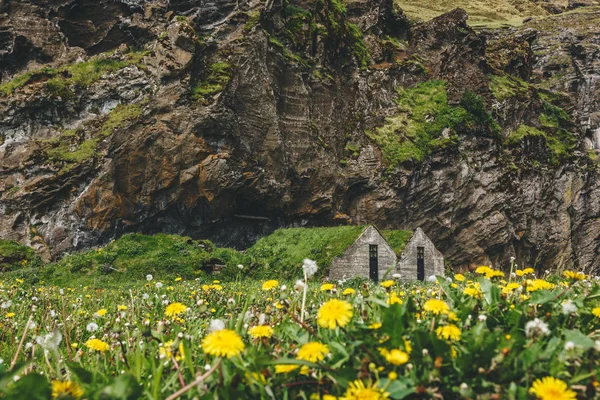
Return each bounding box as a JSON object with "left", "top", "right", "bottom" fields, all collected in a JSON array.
[{"left": 0, "top": 260, "right": 600, "bottom": 400}]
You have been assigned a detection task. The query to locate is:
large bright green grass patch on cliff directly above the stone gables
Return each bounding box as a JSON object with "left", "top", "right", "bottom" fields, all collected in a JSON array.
[{"left": 366, "top": 80, "right": 499, "bottom": 171}]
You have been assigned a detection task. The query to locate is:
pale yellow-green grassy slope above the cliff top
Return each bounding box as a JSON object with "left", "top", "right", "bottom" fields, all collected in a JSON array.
[{"left": 396, "top": 0, "right": 568, "bottom": 28}]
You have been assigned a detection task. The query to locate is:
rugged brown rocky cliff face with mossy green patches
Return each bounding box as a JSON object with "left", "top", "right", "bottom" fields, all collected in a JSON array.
[{"left": 0, "top": 0, "right": 600, "bottom": 271}]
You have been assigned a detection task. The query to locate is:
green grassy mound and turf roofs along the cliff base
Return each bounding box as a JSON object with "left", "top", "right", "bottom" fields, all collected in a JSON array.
[{"left": 0, "top": 225, "right": 412, "bottom": 287}]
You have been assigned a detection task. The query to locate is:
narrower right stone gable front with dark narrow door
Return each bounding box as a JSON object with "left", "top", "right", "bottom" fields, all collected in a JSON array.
[{"left": 396, "top": 228, "right": 444, "bottom": 281}]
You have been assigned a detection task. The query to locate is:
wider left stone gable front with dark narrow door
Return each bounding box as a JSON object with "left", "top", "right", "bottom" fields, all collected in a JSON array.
[{"left": 329, "top": 225, "right": 397, "bottom": 282}]
